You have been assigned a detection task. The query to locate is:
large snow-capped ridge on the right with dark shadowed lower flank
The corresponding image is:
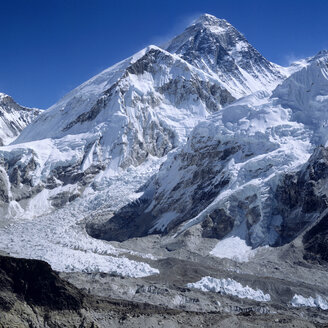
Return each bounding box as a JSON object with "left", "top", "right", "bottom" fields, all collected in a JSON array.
[{"left": 89, "top": 52, "right": 328, "bottom": 247}]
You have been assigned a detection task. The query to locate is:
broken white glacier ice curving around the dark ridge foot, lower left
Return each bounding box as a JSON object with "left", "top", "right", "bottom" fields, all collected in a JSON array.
[{"left": 0, "top": 159, "right": 162, "bottom": 277}]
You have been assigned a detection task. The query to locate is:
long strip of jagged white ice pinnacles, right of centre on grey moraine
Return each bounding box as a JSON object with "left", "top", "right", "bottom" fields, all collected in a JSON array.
[{"left": 187, "top": 276, "right": 271, "bottom": 302}]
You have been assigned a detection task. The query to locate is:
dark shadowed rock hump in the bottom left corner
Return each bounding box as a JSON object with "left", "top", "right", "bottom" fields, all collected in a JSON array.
[{"left": 0, "top": 256, "right": 91, "bottom": 327}]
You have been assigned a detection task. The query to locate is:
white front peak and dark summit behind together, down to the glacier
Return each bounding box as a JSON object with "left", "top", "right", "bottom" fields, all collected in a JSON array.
[{"left": 0, "top": 15, "right": 284, "bottom": 217}]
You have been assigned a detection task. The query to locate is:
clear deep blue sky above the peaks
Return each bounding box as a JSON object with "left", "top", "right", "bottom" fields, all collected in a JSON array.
[{"left": 0, "top": 0, "right": 328, "bottom": 108}]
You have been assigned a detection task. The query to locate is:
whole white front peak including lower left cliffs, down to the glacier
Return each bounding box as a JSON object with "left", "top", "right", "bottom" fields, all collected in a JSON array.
[{"left": 0, "top": 46, "right": 235, "bottom": 215}]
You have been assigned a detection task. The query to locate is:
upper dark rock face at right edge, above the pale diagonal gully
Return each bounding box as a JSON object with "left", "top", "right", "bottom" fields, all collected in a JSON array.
[{"left": 276, "top": 146, "right": 328, "bottom": 245}]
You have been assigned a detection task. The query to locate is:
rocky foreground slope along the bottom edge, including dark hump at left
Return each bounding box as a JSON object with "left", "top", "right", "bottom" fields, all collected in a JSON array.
[{"left": 0, "top": 256, "right": 326, "bottom": 328}]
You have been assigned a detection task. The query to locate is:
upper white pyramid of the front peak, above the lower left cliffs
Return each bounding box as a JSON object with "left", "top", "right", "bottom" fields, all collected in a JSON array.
[{"left": 15, "top": 46, "right": 234, "bottom": 152}]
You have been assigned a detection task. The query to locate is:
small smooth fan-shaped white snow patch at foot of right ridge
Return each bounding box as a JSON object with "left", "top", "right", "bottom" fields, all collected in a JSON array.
[{"left": 210, "top": 236, "right": 258, "bottom": 262}]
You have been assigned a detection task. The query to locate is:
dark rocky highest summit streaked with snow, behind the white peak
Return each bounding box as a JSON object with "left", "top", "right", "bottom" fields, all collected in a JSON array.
[{"left": 164, "top": 14, "right": 289, "bottom": 98}]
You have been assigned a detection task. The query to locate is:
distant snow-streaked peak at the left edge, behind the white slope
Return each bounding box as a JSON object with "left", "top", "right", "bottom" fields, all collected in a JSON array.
[{"left": 0, "top": 93, "right": 41, "bottom": 146}]
